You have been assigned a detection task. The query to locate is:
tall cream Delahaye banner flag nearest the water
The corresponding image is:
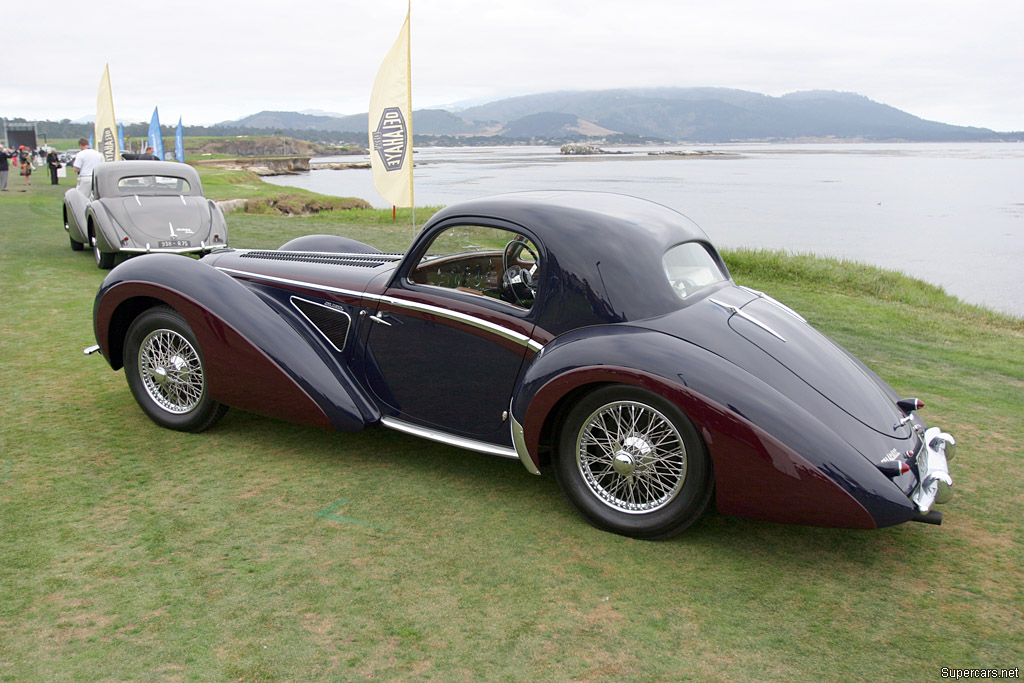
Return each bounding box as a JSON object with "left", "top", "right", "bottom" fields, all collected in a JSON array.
[{"left": 370, "top": 6, "right": 414, "bottom": 207}]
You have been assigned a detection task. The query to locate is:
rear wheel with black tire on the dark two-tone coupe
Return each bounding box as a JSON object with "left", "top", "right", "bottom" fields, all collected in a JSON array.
[{"left": 554, "top": 385, "right": 714, "bottom": 540}]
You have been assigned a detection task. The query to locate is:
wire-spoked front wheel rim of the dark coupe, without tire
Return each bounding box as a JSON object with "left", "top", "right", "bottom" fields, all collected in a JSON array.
[{"left": 138, "top": 330, "right": 205, "bottom": 415}]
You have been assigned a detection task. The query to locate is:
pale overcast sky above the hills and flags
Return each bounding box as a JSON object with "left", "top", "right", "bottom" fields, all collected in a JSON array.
[{"left": 8, "top": 0, "right": 1024, "bottom": 131}]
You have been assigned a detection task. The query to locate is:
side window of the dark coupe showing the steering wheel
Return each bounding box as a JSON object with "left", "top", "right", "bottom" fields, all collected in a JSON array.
[{"left": 409, "top": 225, "right": 541, "bottom": 310}]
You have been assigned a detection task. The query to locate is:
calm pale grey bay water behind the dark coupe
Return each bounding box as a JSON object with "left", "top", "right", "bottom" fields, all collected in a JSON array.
[{"left": 264, "top": 142, "right": 1024, "bottom": 316}]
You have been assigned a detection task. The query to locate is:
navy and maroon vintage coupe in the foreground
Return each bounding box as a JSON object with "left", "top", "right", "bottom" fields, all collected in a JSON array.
[{"left": 87, "top": 193, "right": 954, "bottom": 539}]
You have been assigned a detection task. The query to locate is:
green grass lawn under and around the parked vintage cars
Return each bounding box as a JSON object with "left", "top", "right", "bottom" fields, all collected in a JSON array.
[{"left": 0, "top": 169, "right": 1024, "bottom": 682}]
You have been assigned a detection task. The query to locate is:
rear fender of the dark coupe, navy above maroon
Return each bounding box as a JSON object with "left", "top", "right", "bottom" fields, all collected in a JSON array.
[{"left": 512, "top": 326, "right": 913, "bottom": 528}]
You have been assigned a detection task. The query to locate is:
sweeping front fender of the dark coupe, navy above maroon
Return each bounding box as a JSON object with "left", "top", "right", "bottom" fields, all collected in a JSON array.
[{"left": 93, "top": 254, "right": 380, "bottom": 432}]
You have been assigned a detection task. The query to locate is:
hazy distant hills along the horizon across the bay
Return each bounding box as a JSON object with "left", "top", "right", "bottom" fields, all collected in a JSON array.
[{"left": 214, "top": 88, "right": 1024, "bottom": 142}]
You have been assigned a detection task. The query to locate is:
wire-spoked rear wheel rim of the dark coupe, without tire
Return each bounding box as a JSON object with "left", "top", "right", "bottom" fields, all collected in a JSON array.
[{"left": 577, "top": 401, "right": 686, "bottom": 514}]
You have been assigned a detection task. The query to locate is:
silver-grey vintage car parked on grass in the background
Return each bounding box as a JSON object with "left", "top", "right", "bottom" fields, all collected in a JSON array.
[{"left": 63, "top": 161, "right": 227, "bottom": 269}]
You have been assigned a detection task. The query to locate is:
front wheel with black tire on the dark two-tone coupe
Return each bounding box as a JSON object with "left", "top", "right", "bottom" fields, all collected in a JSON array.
[{"left": 124, "top": 306, "right": 227, "bottom": 432}]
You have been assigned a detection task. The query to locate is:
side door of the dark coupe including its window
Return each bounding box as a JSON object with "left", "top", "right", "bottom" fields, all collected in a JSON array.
[{"left": 366, "top": 220, "right": 542, "bottom": 444}]
